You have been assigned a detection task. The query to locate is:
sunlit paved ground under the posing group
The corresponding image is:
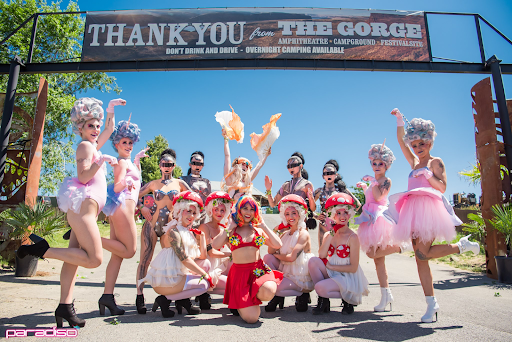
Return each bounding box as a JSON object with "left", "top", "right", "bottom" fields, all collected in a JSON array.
[{"left": 0, "top": 215, "right": 512, "bottom": 342}]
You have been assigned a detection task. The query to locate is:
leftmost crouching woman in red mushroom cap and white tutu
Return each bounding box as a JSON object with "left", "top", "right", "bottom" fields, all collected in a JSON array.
[{"left": 139, "top": 191, "right": 213, "bottom": 317}]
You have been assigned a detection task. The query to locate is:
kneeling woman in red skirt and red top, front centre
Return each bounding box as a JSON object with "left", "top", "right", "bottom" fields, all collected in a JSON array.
[{"left": 212, "top": 196, "right": 283, "bottom": 323}]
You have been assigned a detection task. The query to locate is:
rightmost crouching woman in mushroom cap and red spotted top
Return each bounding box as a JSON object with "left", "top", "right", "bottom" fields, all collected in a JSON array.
[{"left": 309, "top": 193, "right": 369, "bottom": 315}]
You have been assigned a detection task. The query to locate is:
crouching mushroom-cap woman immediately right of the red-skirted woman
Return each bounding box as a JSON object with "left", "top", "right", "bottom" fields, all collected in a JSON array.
[{"left": 263, "top": 194, "right": 314, "bottom": 312}]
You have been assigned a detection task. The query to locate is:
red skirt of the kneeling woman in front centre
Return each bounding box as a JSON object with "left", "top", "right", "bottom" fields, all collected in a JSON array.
[{"left": 223, "top": 259, "right": 283, "bottom": 309}]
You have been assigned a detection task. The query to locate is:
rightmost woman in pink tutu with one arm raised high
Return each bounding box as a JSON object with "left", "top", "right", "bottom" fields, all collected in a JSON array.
[{"left": 384, "top": 108, "right": 480, "bottom": 323}]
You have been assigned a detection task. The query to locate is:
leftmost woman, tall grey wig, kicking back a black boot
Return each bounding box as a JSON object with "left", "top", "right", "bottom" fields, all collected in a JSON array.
[{"left": 18, "top": 98, "right": 126, "bottom": 327}]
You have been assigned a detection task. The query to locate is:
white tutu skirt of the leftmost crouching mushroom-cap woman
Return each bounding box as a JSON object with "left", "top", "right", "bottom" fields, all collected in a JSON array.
[{"left": 138, "top": 248, "right": 187, "bottom": 287}]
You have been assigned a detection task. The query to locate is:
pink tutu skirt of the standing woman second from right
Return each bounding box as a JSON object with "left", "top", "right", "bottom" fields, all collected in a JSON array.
[{"left": 355, "top": 203, "right": 394, "bottom": 253}]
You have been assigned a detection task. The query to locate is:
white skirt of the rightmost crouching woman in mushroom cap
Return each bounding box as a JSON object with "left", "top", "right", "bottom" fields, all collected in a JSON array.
[{"left": 327, "top": 253, "right": 370, "bottom": 305}]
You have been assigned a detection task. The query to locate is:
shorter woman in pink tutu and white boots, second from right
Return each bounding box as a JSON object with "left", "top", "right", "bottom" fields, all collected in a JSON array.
[{"left": 355, "top": 144, "right": 406, "bottom": 311}]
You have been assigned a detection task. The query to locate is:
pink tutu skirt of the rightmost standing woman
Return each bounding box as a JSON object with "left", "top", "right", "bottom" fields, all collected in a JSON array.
[{"left": 384, "top": 188, "right": 462, "bottom": 243}]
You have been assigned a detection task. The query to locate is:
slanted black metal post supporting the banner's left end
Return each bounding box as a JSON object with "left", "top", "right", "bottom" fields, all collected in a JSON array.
[{"left": 0, "top": 56, "right": 23, "bottom": 184}]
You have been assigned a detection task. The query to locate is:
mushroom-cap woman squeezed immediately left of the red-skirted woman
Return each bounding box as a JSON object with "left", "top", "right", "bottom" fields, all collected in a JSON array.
[{"left": 196, "top": 191, "right": 233, "bottom": 310}]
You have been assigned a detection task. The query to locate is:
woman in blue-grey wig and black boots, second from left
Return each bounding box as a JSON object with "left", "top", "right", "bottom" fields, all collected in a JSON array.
[{"left": 98, "top": 119, "right": 147, "bottom": 315}]
